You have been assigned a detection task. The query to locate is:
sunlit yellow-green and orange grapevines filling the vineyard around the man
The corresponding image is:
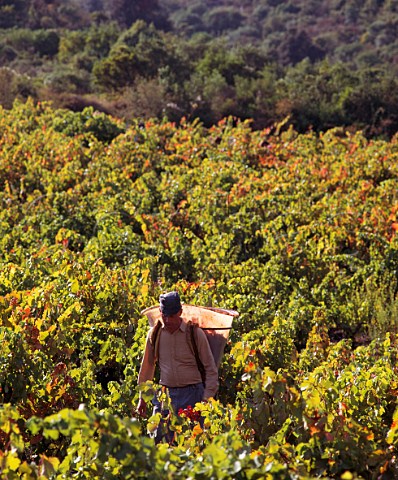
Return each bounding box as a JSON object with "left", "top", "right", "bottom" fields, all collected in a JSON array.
[{"left": 0, "top": 101, "right": 398, "bottom": 480}]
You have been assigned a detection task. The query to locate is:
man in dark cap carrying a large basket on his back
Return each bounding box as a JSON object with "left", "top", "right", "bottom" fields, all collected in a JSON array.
[{"left": 137, "top": 292, "right": 218, "bottom": 441}]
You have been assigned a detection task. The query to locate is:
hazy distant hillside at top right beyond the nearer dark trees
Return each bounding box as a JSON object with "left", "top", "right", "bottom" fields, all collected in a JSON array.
[{"left": 166, "top": 0, "right": 398, "bottom": 68}]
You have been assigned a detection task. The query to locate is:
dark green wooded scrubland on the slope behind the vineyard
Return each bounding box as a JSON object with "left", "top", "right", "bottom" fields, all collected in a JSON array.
[{"left": 0, "top": 0, "right": 398, "bottom": 138}]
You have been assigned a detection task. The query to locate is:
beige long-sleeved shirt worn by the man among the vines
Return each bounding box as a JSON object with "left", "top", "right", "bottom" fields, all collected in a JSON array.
[{"left": 138, "top": 320, "right": 218, "bottom": 400}]
